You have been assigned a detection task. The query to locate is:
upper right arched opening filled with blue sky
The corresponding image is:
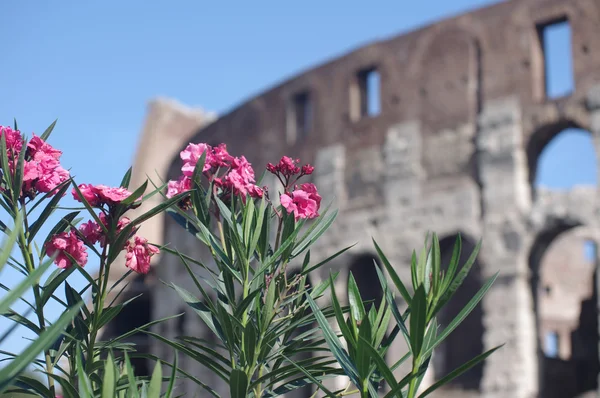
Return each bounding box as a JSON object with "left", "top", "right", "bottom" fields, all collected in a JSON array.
[{"left": 527, "top": 120, "right": 598, "bottom": 194}]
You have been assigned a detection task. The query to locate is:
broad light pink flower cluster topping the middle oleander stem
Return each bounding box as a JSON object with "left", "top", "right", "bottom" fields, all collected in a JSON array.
[{"left": 167, "top": 143, "right": 263, "bottom": 207}]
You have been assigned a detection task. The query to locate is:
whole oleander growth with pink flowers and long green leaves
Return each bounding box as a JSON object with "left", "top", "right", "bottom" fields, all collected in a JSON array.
[{"left": 0, "top": 122, "right": 499, "bottom": 398}]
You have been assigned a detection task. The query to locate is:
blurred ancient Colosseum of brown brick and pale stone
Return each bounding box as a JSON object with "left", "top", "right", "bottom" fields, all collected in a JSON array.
[{"left": 101, "top": 0, "right": 600, "bottom": 398}]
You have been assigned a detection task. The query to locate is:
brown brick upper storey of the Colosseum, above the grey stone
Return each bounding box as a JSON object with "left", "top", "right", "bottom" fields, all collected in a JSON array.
[{"left": 170, "top": 0, "right": 600, "bottom": 182}]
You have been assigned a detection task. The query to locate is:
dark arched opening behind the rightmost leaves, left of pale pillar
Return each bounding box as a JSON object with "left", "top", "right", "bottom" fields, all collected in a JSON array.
[{"left": 432, "top": 234, "right": 485, "bottom": 393}]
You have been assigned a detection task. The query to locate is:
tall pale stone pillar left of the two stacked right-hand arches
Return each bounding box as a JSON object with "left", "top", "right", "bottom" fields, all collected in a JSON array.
[{"left": 477, "top": 98, "right": 538, "bottom": 398}]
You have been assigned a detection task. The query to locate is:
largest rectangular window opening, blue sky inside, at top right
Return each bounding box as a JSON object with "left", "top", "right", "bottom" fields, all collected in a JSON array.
[{"left": 538, "top": 18, "right": 575, "bottom": 99}]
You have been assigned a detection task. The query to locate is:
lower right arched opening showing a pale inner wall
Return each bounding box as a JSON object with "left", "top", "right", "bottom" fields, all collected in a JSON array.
[{"left": 529, "top": 221, "right": 600, "bottom": 398}]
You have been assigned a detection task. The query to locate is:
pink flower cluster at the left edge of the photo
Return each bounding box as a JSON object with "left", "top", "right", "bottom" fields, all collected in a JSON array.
[{"left": 0, "top": 126, "right": 70, "bottom": 198}]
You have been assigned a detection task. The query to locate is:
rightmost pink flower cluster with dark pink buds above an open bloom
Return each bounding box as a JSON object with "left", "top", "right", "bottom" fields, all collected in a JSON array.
[{"left": 267, "top": 156, "right": 321, "bottom": 221}]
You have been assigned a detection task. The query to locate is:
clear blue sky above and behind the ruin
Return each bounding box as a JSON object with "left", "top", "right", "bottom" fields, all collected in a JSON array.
[{"left": 0, "top": 0, "right": 596, "bottom": 358}]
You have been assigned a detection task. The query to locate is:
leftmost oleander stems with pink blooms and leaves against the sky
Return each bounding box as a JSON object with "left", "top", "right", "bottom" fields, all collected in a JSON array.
[{"left": 0, "top": 123, "right": 178, "bottom": 397}]
